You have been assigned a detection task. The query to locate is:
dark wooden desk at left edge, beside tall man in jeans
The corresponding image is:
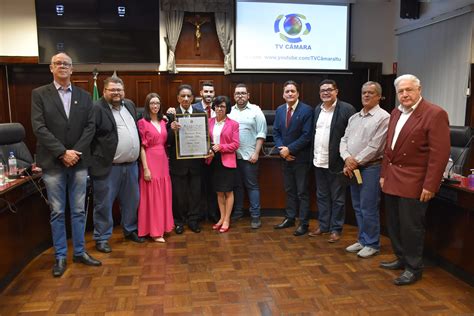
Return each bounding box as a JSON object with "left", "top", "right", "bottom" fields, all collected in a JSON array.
[{"left": 0, "top": 175, "right": 52, "bottom": 290}]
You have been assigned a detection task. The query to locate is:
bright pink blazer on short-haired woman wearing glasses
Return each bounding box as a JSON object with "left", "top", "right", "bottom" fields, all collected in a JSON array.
[{"left": 208, "top": 117, "right": 240, "bottom": 168}]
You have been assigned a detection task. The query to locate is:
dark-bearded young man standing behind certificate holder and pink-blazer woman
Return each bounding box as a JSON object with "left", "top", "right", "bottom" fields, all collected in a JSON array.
[{"left": 192, "top": 81, "right": 220, "bottom": 223}]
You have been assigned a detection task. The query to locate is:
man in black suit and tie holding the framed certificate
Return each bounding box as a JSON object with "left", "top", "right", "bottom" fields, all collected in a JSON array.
[{"left": 167, "top": 84, "right": 204, "bottom": 234}]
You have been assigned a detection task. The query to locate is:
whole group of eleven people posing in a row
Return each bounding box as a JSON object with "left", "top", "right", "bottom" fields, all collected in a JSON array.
[{"left": 31, "top": 53, "right": 449, "bottom": 285}]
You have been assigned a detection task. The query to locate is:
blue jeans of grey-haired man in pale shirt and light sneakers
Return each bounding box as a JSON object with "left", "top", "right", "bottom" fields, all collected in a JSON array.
[{"left": 351, "top": 165, "right": 381, "bottom": 250}]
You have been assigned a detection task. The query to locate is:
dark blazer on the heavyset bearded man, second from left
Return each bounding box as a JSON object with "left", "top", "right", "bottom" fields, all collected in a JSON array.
[{"left": 89, "top": 97, "right": 138, "bottom": 177}]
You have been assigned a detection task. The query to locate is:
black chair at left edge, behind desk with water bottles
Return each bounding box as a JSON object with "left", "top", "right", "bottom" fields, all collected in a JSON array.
[{"left": 0, "top": 123, "right": 33, "bottom": 168}]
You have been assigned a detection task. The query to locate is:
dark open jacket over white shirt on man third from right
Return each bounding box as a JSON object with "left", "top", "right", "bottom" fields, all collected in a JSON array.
[{"left": 311, "top": 99, "right": 356, "bottom": 173}]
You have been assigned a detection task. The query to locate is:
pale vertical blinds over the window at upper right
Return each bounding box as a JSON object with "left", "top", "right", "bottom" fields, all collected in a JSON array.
[{"left": 398, "top": 12, "right": 474, "bottom": 126}]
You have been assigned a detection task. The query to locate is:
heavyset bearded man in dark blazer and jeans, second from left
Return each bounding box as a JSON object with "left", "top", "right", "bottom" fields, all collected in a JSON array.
[{"left": 90, "top": 76, "right": 145, "bottom": 253}]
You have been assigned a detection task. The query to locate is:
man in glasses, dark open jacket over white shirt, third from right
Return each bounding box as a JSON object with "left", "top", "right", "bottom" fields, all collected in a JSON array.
[{"left": 309, "top": 79, "right": 356, "bottom": 243}]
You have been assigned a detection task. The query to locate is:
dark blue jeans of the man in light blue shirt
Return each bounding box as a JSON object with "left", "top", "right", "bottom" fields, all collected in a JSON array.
[{"left": 234, "top": 159, "right": 260, "bottom": 217}]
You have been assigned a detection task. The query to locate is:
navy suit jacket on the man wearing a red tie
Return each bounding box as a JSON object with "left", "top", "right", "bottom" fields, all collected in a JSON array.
[{"left": 273, "top": 101, "right": 313, "bottom": 163}]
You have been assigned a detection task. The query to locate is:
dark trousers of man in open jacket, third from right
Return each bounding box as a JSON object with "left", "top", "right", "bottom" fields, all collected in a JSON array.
[{"left": 314, "top": 167, "right": 347, "bottom": 233}]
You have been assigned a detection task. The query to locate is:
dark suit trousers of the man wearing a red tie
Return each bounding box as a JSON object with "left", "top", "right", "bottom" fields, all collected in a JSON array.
[{"left": 282, "top": 161, "right": 311, "bottom": 225}]
